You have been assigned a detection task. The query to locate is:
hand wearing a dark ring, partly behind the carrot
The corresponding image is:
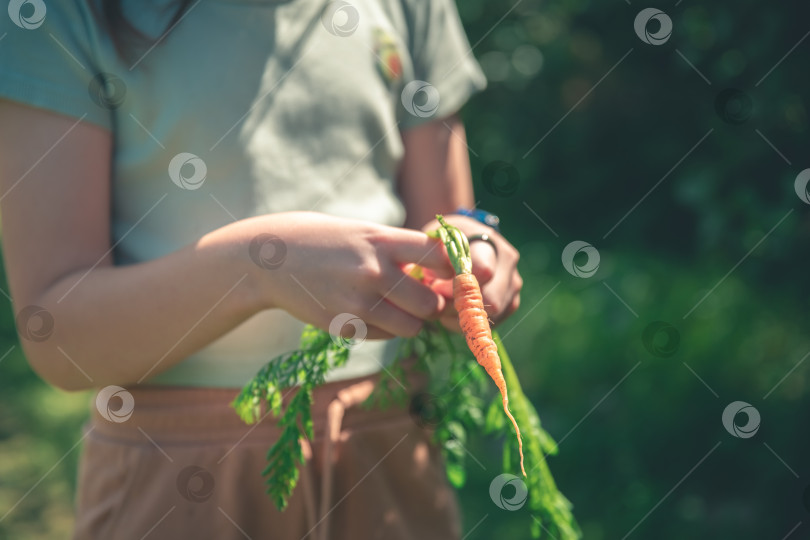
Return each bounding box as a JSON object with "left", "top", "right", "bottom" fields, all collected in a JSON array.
[{"left": 422, "top": 215, "right": 523, "bottom": 332}]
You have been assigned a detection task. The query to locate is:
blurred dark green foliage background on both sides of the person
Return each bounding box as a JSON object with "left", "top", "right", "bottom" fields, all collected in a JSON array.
[{"left": 0, "top": 0, "right": 810, "bottom": 540}]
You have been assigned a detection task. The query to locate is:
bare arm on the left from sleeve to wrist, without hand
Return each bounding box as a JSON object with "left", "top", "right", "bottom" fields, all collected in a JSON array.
[{"left": 0, "top": 102, "right": 266, "bottom": 389}]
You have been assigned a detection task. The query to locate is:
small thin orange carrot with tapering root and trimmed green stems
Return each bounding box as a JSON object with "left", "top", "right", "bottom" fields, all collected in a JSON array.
[{"left": 436, "top": 216, "right": 526, "bottom": 476}]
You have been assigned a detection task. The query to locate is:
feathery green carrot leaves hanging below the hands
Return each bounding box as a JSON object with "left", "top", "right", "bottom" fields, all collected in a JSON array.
[{"left": 232, "top": 325, "right": 580, "bottom": 540}]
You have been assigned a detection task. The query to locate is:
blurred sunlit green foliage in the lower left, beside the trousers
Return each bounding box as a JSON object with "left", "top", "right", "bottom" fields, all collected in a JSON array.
[{"left": 0, "top": 269, "right": 90, "bottom": 540}]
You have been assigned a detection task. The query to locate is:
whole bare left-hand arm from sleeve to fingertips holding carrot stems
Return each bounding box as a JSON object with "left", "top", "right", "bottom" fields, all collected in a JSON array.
[{"left": 0, "top": 100, "right": 449, "bottom": 389}]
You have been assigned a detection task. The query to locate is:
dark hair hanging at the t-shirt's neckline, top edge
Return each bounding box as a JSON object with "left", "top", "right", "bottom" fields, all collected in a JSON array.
[{"left": 87, "top": 0, "right": 194, "bottom": 60}]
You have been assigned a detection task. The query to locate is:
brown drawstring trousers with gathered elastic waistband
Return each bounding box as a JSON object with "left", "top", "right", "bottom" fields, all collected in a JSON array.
[{"left": 74, "top": 376, "right": 461, "bottom": 540}]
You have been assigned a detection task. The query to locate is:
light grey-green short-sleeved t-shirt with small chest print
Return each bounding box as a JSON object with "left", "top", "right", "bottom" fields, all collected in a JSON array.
[{"left": 0, "top": 0, "right": 486, "bottom": 387}]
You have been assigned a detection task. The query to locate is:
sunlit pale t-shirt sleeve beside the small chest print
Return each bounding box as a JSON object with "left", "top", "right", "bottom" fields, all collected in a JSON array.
[{"left": 398, "top": 0, "right": 487, "bottom": 130}]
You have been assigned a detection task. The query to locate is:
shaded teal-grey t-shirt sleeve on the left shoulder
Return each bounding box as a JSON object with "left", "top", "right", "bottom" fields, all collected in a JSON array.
[{"left": 0, "top": 0, "right": 112, "bottom": 129}]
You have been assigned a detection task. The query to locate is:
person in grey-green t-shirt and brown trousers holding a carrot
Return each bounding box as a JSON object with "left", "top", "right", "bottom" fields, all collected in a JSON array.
[{"left": 0, "top": 0, "right": 521, "bottom": 539}]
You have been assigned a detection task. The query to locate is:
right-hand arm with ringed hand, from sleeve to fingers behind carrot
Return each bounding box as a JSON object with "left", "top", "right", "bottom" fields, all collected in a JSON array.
[{"left": 399, "top": 116, "right": 523, "bottom": 329}]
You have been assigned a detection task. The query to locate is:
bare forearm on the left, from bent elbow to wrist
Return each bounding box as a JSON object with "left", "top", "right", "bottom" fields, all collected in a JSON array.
[{"left": 21, "top": 224, "right": 265, "bottom": 389}]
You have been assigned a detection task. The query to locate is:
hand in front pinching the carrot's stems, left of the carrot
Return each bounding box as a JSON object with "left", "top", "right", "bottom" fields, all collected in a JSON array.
[{"left": 234, "top": 212, "right": 453, "bottom": 339}]
